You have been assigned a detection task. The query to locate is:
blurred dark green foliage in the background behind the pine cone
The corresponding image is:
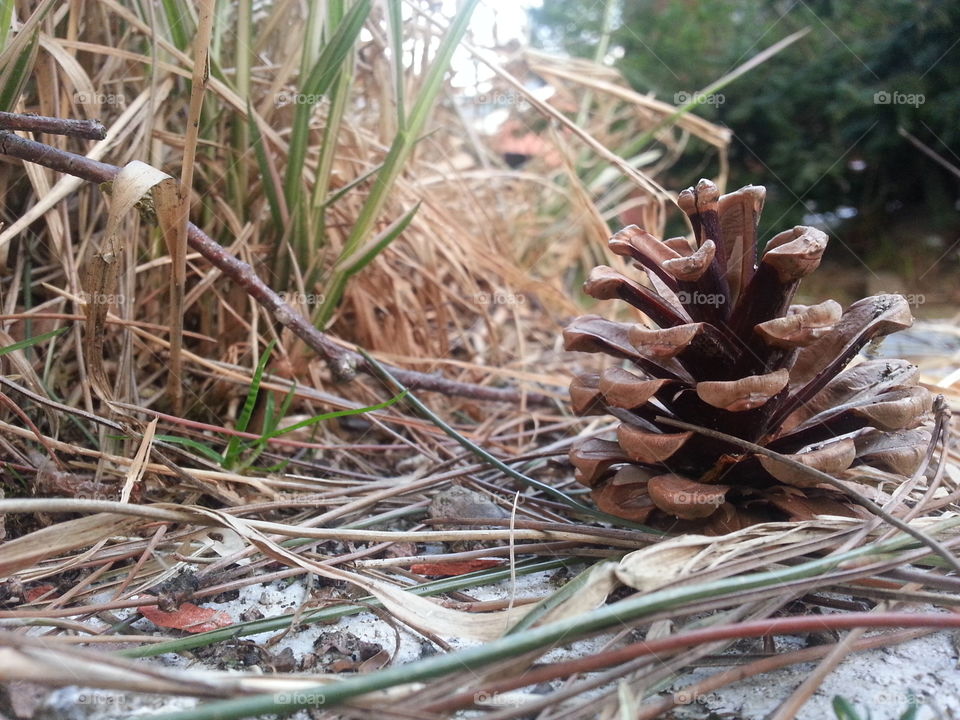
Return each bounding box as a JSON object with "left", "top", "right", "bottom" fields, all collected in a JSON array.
[{"left": 531, "top": 0, "right": 960, "bottom": 280}]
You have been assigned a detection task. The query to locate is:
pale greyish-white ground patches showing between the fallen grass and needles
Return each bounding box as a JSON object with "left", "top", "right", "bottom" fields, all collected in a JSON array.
[{"left": 26, "top": 573, "right": 960, "bottom": 720}]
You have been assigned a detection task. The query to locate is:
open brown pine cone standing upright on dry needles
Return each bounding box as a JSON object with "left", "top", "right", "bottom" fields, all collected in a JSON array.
[{"left": 563, "top": 180, "right": 932, "bottom": 533}]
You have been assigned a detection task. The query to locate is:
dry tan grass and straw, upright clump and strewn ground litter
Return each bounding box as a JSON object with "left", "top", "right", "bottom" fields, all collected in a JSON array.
[{"left": 0, "top": 0, "right": 960, "bottom": 718}]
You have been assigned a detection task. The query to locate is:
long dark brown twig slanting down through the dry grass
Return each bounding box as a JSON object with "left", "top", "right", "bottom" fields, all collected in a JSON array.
[{"left": 0, "top": 128, "right": 553, "bottom": 406}]
